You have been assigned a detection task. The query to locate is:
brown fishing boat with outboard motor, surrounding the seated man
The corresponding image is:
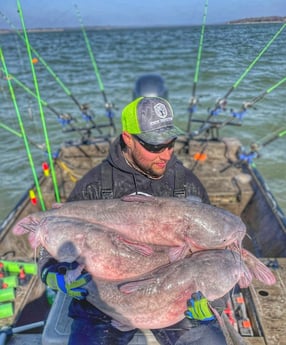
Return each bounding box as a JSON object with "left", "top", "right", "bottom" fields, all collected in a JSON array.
[{"left": 0, "top": 74, "right": 286, "bottom": 345}]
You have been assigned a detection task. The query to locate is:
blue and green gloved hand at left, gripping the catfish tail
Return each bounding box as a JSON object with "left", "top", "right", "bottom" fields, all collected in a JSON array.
[{"left": 41, "top": 262, "right": 91, "bottom": 300}]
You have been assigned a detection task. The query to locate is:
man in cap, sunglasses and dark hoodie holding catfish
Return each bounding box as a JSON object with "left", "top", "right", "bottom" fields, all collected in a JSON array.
[{"left": 40, "top": 97, "right": 226, "bottom": 345}]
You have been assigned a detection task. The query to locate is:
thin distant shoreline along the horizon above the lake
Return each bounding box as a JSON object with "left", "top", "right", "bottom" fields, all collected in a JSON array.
[{"left": 0, "top": 16, "right": 286, "bottom": 34}]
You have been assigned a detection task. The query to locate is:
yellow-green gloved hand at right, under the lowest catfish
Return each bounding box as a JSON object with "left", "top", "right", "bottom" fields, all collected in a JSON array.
[{"left": 185, "top": 291, "right": 215, "bottom": 322}]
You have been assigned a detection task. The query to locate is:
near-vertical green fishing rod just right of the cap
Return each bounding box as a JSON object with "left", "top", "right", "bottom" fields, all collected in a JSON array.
[{"left": 187, "top": 0, "right": 208, "bottom": 133}]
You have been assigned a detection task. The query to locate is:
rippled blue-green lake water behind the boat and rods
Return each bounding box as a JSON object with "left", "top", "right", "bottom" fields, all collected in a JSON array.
[{"left": 0, "top": 24, "right": 286, "bottom": 221}]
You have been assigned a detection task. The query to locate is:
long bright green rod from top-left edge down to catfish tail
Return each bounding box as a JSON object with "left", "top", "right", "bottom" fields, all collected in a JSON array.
[{"left": 17, "top": 0, "right": 60, "bottom": 202}]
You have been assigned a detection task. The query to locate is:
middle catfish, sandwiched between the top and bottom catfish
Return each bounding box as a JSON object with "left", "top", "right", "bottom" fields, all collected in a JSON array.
[{"left": 20, "top": 216, "right": 173, "bottom": 280}]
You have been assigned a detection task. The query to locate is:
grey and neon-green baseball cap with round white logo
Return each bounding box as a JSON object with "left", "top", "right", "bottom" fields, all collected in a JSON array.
[{"left": 121, "top": 97, "right": 183, "bottom": 145}]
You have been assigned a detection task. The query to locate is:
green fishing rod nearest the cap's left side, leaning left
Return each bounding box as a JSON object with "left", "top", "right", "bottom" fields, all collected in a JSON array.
[{"left": 74, "top": 5, "right": 116, "bottom": 131}]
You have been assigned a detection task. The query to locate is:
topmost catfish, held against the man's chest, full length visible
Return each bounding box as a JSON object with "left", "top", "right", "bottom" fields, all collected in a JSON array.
[{"left": 14, "top": 195, "right": 246, "bottom": 258}]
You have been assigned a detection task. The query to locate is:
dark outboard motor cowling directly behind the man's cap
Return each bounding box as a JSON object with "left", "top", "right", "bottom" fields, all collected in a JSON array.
[{"left": 133, "top": 74, "right": 168, "bottom": 99}]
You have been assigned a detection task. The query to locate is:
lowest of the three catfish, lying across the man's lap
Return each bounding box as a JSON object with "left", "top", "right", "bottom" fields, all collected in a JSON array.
[{"left": 81, "top": 249, "right": 252, "bottom": 329}]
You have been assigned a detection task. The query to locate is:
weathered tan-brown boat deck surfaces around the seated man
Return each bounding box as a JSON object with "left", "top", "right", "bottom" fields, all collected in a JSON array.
[{"left": 0, "top": 138, "right": 286, "bottom": 345}]
